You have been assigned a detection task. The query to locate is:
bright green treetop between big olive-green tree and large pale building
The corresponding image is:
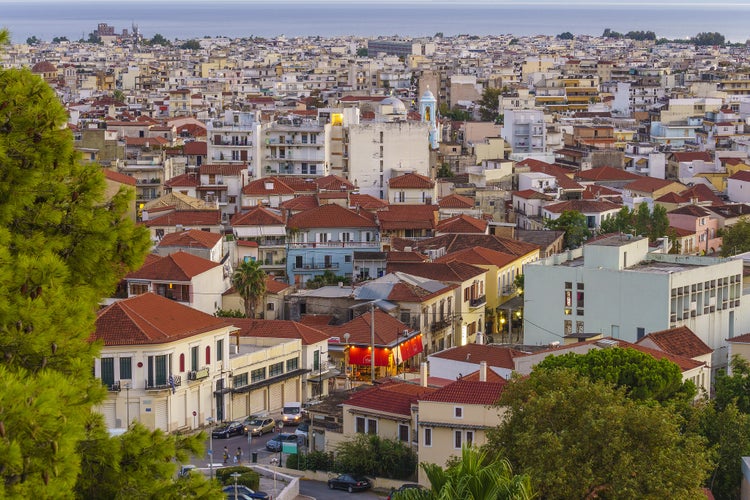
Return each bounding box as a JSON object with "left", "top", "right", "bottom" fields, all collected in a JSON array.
[{"left": 535, "top": 347, "right": 696, "bottom": 403}]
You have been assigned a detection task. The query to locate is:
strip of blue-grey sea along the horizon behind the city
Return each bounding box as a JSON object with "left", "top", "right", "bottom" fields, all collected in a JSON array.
[{"left": 0, "top": 0, "right": 750, "bottom": 43}]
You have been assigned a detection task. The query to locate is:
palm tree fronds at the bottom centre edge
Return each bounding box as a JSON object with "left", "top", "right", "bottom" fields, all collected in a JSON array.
[{"left": 398, "top": 447, "right": 536, "bottom": 500}]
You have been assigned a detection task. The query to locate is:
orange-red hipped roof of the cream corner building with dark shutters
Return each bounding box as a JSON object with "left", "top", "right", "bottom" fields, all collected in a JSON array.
[{"left": 89, "top": 293, "right": 225, "bottom": 346}]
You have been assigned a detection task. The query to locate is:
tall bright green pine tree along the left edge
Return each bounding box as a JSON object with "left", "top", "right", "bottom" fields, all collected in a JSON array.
[{"left": 0, "top": 59, "right": 150, "bottom": 498}]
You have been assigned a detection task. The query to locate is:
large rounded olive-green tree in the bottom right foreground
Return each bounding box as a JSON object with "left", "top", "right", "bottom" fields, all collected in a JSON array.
[{"left": 486, "top": 370, "right": 711, "bottom": 499}]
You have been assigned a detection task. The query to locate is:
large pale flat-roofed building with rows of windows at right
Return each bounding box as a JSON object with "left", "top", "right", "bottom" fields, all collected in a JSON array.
[{"left": 524, "top": 236, "right": 750, "bottom": 367}]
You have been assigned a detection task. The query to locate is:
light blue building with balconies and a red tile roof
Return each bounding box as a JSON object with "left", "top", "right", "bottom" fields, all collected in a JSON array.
[{"left": 286, "top": 204, "right": 380, "bottom": 286}]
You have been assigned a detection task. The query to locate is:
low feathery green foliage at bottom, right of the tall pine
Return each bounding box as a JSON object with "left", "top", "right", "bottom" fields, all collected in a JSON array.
[{"left": 75, "top": 420, "right": 222, "bottom": 499}]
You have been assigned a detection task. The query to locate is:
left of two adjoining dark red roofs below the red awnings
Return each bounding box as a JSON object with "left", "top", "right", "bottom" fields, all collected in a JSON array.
[{"left": 344, "top": 381, "right": 436, "bottom": 418}]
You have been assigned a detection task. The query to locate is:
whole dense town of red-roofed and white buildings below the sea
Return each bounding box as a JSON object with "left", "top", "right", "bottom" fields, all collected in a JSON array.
[{"left": 7, "top": 23, "right": 750, "bottom": 498}]
